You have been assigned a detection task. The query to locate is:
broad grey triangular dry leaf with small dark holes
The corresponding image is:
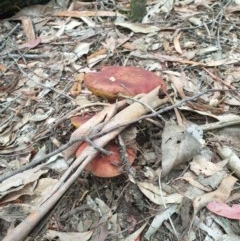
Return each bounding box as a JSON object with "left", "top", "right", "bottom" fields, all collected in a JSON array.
[{"left": 162, "top": 122, "right": 201, "bottom": 176}]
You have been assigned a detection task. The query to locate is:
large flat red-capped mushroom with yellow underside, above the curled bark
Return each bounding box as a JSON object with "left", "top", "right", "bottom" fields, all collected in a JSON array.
[{"left": 84, "top": 66, "right": 167, "bottom": 100}]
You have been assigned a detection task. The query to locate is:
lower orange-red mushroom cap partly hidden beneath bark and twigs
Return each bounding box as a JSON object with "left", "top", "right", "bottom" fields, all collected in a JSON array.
[{"left": 76, "top": 142, "right": 136, "bottom": 177}]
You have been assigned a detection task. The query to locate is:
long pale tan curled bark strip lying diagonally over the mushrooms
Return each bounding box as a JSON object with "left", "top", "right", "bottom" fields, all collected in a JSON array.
[{"left": 3, "top": 88, "right": 168, "bottom": 241}]
